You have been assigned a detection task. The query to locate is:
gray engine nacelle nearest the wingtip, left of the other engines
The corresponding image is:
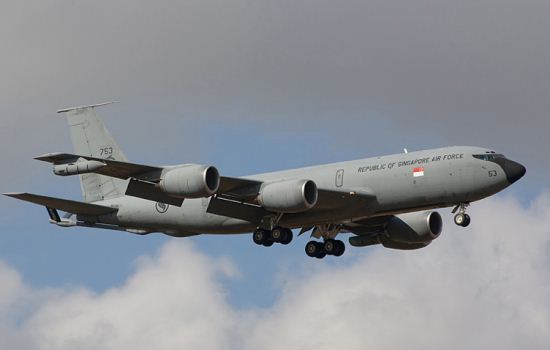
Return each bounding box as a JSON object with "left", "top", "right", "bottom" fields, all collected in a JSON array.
[{"left": 159, "top": 164, "right": 220, "bottom": 198}]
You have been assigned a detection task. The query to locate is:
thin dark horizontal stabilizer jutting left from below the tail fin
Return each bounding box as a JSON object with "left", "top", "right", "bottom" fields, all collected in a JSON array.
[{"left": 4, "top": 193, "right": 118, "bottom": 216}]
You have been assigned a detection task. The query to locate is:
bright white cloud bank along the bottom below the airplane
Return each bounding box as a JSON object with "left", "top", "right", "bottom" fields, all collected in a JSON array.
[{"left": 0, "top": 195, "right": 550, "bottom": 349}]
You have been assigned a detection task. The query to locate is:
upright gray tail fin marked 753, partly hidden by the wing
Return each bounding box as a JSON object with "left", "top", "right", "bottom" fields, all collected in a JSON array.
[{"left": 57, "top": 102, "right": 128, "bottom": 202}]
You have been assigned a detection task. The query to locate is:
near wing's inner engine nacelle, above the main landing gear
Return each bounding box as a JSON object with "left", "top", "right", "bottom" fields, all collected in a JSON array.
[{"left": 258, "top": 180, "right": 318, "bottom": 213}]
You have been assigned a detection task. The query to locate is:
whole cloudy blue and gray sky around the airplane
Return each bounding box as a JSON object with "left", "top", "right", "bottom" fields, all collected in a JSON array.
[{"left": 0, "top": 0, "right": 550, "bottom": 349}]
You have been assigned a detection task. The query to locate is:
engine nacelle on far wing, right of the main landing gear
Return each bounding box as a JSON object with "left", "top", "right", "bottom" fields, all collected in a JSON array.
[{"left": 386, "top": 211, "right": 443, "bottom": 244}]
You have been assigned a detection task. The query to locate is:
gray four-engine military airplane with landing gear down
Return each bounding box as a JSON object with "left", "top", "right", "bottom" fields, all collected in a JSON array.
[{"left": 4, "top": 102, "right": 526, "bottom": 259}]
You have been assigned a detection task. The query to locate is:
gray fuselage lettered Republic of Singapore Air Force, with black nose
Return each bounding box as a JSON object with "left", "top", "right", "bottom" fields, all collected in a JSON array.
[{"left": 97, "top": 146, "right": 525, "bottom": 236}]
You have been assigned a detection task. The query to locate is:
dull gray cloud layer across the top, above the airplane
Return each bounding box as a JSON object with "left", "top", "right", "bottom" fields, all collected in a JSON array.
[{"left": 0, "top": 0, "right": 550, "bottom": 189}]
